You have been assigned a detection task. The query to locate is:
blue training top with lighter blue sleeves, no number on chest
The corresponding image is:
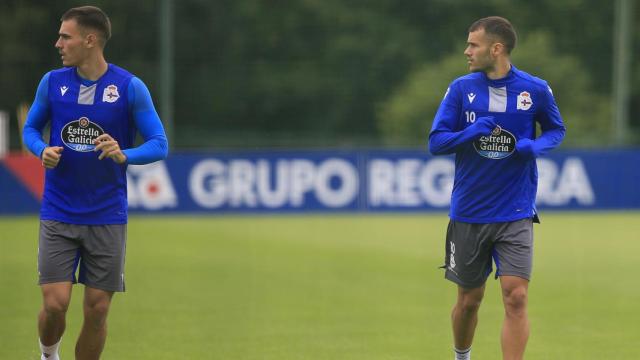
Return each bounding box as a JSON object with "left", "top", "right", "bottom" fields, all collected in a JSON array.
[{"left": 23, "top": 64, "right": 168, "bottom": 225}]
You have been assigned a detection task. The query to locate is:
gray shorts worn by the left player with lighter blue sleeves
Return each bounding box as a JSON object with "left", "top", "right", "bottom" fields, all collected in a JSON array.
[{"left": 38, "top": 220, "right": 127, "bottom": 291}]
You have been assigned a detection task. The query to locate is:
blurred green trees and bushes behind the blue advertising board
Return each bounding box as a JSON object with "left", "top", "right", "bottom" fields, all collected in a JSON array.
[{"left": 0, "top": 0, "right": 640, "bottom": 148}]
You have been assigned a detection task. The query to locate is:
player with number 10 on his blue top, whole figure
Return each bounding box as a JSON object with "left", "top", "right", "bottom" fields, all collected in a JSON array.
[{"left": 429, "top": 16, "right": 565, "bottom": 360}]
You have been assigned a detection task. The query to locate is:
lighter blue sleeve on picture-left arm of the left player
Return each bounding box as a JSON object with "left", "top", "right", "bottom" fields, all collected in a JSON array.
[{"left": 22, "top": 73, "right": 49, "bottom": 157}]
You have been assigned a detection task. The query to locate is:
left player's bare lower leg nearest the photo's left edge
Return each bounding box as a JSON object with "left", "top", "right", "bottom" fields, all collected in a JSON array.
[{"left": 38, "top": 282, "right": 71, "bottom": 346}]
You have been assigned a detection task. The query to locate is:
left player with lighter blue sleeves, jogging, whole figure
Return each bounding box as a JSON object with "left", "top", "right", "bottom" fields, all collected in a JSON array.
[{"left": 23, "top": 6, "right": 168, "bottom": 360}]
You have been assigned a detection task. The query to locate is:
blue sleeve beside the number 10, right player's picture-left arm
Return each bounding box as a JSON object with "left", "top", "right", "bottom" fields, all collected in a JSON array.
[{"left": 429, "top": 83, "right": 490, "bottom": 155}]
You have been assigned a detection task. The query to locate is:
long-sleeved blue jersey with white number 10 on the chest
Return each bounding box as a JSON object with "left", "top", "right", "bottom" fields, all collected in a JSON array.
[{"left": 429, "top": 65, "right": 565, "bottom": 223}]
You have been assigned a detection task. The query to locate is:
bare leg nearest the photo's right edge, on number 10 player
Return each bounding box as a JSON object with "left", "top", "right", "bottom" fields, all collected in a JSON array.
[{"left": 500, "top": 276, "right": 529, "bottom": 360}]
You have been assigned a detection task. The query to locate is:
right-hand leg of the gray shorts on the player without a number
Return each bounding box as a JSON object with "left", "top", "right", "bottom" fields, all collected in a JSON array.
[{"left": 78, "top": 224, "right": 127, "bottom": 291}]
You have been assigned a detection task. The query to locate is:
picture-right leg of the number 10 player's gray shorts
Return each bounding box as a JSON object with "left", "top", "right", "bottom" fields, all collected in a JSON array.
[{"left": 494, "top": 219, "right": 533, "bottom": 280}]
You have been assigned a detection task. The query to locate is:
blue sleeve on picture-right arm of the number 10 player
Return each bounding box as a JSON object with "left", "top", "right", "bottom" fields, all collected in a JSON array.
[{"left": 516, "top": 86, "right": 566, "bottom": 158}]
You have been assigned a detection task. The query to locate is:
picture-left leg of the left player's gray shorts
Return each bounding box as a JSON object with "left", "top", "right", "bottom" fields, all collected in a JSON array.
[{"left": 38, "top": 220, "right": 80, "bottom": 285}]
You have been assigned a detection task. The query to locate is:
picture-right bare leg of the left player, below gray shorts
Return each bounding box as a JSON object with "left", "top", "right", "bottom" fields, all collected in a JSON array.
[{"left": 76, "top": 286, "right": 113, "bottom": 360}]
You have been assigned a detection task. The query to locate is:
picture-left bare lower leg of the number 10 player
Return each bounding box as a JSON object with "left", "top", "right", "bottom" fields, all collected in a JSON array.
[{"left": 451, "top": 284, "right": 485, "bottom": 350}]
